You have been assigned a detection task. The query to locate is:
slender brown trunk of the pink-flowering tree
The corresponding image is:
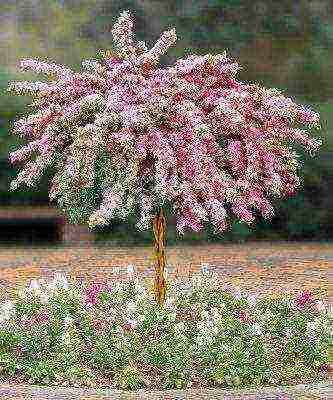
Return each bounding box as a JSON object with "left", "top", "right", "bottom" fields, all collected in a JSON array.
[{"left": 153, "top": 207, "right": 166, "bottom": 307}]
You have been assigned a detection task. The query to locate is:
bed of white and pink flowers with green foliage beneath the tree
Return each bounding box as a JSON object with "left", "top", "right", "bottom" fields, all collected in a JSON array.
[{"left": 0, "top": 270, "right": 332, "bottom": 390}]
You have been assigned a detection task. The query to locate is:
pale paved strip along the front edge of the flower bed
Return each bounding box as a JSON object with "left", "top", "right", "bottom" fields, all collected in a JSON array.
[{"left": 0, "top": 382, "right": 333, "bottom": 400}]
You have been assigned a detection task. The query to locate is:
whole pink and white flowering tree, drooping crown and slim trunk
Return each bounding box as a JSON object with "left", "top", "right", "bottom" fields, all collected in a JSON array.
[{"left": 8, "top": 11, "right": 321, "bottom": 304}]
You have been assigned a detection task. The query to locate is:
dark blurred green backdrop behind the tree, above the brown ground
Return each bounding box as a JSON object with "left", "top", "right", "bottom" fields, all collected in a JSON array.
[{"left": 0, "top": 0, "right": 333, "bottom": 246}]
